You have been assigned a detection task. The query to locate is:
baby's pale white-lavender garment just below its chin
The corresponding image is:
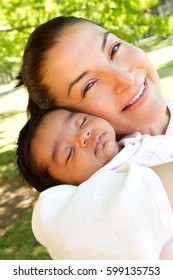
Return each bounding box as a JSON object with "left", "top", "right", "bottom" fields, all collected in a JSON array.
[{"left": 103, "top": 132, "right": 173, "bottom": 170}]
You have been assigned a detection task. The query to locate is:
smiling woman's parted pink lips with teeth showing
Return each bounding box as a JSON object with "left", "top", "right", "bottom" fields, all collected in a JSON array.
[{"left": 122, "top": 79, "right": 148, "bottom": 112}]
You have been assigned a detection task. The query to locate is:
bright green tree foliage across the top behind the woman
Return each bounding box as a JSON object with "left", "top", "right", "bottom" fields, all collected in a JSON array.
[{"left": 0, "top": 0, "right": 173, "bottom": 80}]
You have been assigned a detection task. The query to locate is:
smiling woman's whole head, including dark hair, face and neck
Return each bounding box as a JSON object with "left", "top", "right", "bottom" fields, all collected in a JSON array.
[{"left": 19, "top": 17, "right": 170, "bottom": 135}]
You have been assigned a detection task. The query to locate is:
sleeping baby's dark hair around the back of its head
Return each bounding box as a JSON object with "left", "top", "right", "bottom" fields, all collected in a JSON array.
[{"left": 16, "top": 108, "right": 61, "bottom": 192}]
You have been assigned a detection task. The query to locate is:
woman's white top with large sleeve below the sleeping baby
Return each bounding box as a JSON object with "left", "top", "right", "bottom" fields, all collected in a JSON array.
[{"left": 32, "top": 99, "right": 173, "bottom": 260}]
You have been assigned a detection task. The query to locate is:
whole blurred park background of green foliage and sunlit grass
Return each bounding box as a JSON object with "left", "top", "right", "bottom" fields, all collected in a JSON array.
[{"left": 0, "top": 0, "right": 173, "bottom": 260}]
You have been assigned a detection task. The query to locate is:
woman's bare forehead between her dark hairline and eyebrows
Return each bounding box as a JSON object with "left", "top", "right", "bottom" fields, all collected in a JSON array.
[{"left": 44, "top": 23, "right": 112, "bottom": 73}]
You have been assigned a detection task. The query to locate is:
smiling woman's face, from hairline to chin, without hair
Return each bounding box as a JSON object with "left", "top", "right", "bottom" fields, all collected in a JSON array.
[{"left": 42, "top": 23, "right": 166, "bottom": 134}]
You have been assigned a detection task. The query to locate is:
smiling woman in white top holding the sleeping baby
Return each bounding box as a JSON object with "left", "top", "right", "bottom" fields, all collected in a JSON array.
[{"left": 17, "top": 17, "right": 173, "bottom": 259}]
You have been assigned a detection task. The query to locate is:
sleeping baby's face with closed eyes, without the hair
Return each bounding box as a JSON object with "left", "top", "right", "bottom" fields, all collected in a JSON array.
[{"left": 31, "top": 110, "right": 119, "bottom": 185}]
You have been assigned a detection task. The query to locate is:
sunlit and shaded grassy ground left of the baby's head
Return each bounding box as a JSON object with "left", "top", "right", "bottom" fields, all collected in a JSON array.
[{"left": 0, "top": 83, "right": 50, "bottom": 260}]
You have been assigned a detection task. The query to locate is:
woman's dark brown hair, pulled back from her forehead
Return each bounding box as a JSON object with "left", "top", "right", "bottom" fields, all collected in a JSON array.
[{"left": 17, "top": 16, "right": 93, "bottom": 116}]
